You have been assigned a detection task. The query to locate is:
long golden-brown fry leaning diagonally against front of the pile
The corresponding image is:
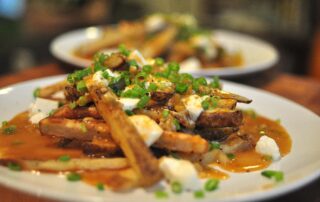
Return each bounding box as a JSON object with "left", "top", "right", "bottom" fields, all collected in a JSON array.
[{"left": 85, "top": 77, "right": 162, "bottom": 186}]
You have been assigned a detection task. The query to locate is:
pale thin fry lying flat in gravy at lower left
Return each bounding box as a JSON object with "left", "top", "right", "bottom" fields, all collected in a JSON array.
[{"left": 18, "top": 158, "right": 129, "bottom": 171}]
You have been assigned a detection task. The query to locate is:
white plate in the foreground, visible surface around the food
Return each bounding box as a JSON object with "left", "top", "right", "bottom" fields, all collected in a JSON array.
[{"left": 0, "top": 76, "right": 320, "bottom": 202}]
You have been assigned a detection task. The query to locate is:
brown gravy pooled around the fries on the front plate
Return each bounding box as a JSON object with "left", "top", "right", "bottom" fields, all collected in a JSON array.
[{"left": 0, "top": 112, "right": 291, "bottom": 186}]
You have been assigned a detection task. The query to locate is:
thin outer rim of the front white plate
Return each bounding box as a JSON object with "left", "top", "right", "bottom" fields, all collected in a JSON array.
[{"left": 0, "top": 74, "right": 320, "bottom": 201}]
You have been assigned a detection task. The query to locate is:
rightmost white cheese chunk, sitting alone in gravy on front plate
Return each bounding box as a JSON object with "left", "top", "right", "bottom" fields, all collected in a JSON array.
[{"left": 255, "top": 135, "right": 281, "bottom": 161}]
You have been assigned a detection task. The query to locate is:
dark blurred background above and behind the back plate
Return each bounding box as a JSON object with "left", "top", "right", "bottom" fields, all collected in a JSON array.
[{"left": 0, "top": 0, "right": 320, "bottom": 80}]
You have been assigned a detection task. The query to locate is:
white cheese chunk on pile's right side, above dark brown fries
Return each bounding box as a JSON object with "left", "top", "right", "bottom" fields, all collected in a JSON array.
[{"left": 181, "top": 95, "right": 208, "bottom": 121}]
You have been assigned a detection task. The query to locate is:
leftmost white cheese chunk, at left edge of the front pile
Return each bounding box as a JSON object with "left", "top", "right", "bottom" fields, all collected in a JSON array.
[{"left": 29, "top": 98, "right": 59, "bottom": 124}]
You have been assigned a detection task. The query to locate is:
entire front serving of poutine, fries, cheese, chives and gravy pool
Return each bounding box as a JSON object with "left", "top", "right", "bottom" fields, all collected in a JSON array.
[{"left": 0, "top": 46, "right": 291, "bottom": 196}]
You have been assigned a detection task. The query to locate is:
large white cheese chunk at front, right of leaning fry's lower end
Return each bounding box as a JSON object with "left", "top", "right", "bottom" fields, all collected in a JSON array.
[{"left": 159, "top": 157, "right": 201, "bottom": 190}]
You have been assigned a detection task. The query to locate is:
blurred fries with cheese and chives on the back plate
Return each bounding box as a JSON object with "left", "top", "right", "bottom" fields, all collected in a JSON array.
[{"left": 75, "top": 14, "right": 244, "bottom": 70}]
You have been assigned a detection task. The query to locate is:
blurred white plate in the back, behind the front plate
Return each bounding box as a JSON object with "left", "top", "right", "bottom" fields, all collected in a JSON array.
[{"left": 50, "top": 27, "right": 279, "bottom": 77}]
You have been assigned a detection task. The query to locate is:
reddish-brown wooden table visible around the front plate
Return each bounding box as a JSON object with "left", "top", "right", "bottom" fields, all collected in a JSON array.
[{"left": 0, "top": 64, "right": 320, "bottom": 202}]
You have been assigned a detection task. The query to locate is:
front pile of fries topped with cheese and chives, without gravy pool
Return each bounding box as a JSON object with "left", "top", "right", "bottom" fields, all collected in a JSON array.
[{"left": 12, "top": 46, "right": 251, "bottom": 190}]
